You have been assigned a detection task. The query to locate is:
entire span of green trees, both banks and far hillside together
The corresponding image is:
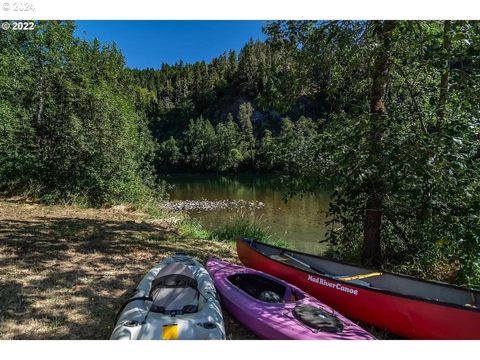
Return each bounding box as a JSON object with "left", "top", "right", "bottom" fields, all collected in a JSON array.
[{"left": 0, "top": 20, "right": 480, "bottom": 286}]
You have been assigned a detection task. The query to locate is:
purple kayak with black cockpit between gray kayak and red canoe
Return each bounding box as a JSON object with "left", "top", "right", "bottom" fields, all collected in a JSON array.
[{"left": 207, "top": 258, "right": 375, "bottom": 340}]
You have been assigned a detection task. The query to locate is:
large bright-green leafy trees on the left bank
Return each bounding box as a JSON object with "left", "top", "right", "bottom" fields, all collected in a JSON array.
[{"left": 0, "top": 22, "right": 159, "bottom": 205}]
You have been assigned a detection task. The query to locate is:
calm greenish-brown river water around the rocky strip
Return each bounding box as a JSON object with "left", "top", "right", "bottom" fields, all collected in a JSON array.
[{"left": 166, "top": 176, "right": 329, "bottom": 253}]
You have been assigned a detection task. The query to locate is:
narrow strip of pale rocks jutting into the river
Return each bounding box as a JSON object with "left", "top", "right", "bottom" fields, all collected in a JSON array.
[{"left": 160, "top": 199, "right": 265, "bottom": 211}]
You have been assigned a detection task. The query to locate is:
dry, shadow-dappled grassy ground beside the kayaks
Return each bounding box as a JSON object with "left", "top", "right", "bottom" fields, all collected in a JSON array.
[{"left": 0, "top": 200, "right": 255, "bottom": 339}]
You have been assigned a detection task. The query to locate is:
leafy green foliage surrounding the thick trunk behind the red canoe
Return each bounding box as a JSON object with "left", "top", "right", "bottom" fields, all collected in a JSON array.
[{"left": 267, "top": 21, "right": 480, "bottom": 286}]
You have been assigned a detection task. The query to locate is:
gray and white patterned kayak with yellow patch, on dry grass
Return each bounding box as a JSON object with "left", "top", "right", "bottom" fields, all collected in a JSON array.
[{"left": 110, "top": 254, "right": 225, "bottom": 340}]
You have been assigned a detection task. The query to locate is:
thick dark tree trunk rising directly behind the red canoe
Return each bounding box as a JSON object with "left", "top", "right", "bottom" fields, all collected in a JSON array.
[{"left": 362, "top": 21, "right": 396, "bottom": 266}]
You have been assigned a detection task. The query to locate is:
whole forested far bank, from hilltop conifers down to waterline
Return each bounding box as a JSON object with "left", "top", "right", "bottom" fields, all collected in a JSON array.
[{"left": 132, "top": 41, "right": 320, "bottom": 173}]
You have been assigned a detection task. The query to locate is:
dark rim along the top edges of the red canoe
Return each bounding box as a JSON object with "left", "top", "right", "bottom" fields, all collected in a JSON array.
[{"left": 237, "top": 238, "right": 480, "bottom": 313}]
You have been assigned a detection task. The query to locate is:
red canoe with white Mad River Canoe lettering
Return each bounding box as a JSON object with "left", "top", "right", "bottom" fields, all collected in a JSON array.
[{"left": 237, "top": 239, "right": 480, "bottom": 339}]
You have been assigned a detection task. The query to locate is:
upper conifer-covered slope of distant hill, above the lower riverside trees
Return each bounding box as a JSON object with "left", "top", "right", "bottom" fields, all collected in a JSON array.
[{"left": 131, "top": 41, "right": 325, "bottom": 141}]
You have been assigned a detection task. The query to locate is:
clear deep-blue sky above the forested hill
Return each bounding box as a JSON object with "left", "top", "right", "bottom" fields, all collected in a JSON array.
[{"left": 76, "top": 20, "right": 265, "bottom": 69}]
